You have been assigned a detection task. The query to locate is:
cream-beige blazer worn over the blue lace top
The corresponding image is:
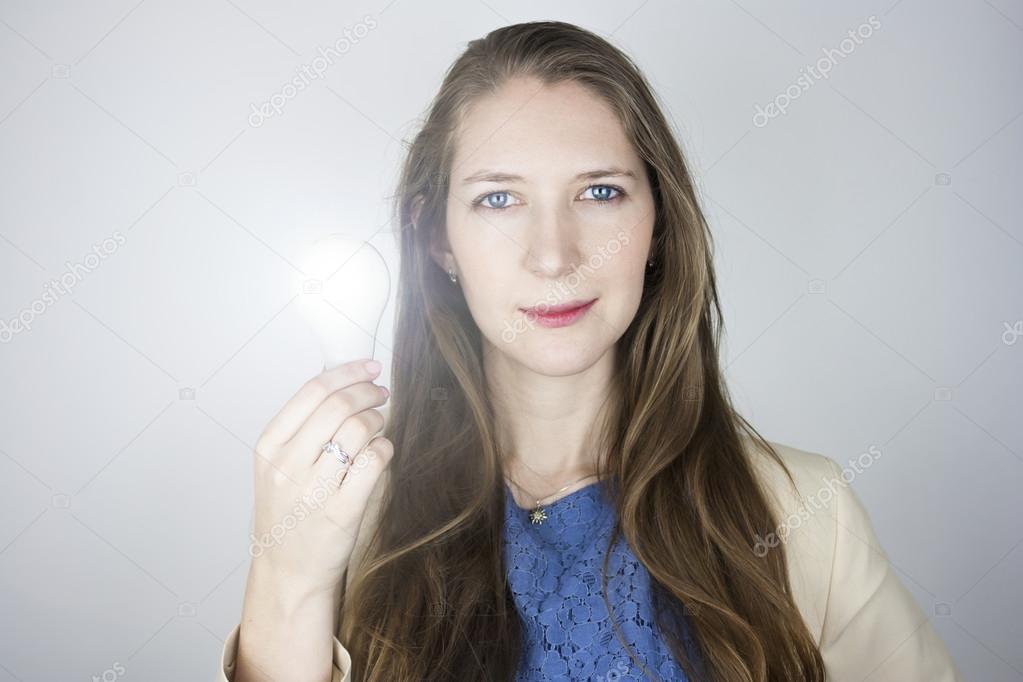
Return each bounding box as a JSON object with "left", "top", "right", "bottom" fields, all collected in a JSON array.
[{"left": 216, "top": 441, "right": 963, "bottom": 682}]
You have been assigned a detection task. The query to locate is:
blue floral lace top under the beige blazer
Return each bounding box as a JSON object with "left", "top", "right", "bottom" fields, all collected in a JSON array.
[{"left": 503, "top": 482, "right": 699, "bottom": 682}]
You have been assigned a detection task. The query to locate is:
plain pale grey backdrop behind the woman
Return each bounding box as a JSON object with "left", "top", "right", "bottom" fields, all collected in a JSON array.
[{"left": 0, "top": 0, "right": 1023, "bottom": 682}]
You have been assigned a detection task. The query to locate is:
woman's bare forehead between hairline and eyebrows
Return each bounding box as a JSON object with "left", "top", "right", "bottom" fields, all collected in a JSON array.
[{"left": 452, "top": 79, "right": 640, "bottom": 182}]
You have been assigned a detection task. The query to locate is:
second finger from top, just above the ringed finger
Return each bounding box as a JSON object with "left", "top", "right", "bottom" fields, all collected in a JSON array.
[{"left": 281, "top": 381, "right": 388, "bottom": 468}]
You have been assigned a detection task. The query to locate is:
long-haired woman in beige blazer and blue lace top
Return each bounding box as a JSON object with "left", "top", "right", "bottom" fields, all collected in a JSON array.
[{"left": 220, "top": 21, "right": 962, "bottom": 682}]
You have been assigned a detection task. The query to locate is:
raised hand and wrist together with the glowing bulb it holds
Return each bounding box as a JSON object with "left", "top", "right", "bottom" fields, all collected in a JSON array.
[{"left": 236, "top": 235, "right": 394, "bottom": 679}]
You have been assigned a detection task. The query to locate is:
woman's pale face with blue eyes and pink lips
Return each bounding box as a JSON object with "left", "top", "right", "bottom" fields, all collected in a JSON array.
[{"left": 433, "top": 79, "right": 655, "bottom": 375}]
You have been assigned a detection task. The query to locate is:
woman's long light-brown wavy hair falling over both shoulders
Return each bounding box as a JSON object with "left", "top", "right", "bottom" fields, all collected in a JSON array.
[{"left": 341, "top": 21, "right": 825, "bottom": 682}]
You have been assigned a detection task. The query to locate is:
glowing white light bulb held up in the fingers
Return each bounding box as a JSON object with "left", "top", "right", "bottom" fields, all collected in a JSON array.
[{"left": 293, "top": 234, "right": 391, "bottom": 369}]
